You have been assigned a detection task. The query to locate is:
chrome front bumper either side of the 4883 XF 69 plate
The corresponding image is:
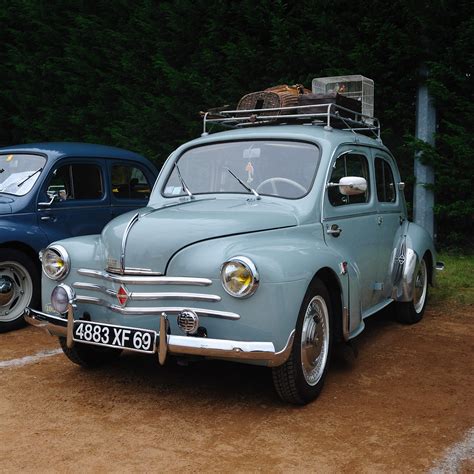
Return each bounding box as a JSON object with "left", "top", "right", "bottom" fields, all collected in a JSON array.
[{"left": 24, "top": 305, "right": 294, "bottom": 367}]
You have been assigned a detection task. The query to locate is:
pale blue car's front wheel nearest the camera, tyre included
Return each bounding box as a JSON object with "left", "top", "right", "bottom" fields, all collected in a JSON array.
[{"left": 272, "top": 280, "right": 333, "bottom": 405}]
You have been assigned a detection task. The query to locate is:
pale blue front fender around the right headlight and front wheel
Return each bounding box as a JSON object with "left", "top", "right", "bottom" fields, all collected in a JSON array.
[{"left": 167, "top": 224, "right": 348, "bottom": 350}]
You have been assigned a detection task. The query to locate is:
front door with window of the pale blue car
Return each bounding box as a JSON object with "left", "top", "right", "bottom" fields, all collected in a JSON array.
[{"left": 323, "top": 147, "right": 378, "bottom": 316}]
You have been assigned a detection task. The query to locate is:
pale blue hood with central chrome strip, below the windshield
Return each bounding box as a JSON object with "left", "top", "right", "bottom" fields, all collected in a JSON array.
[{"left": 102, "top": 199, "right": 298, "bottom": 274}]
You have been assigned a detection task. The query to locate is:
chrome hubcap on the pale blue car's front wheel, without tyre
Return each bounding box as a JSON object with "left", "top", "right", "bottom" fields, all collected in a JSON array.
[{"left": 301, "top": 296, "right": 329, "bottom": 385}]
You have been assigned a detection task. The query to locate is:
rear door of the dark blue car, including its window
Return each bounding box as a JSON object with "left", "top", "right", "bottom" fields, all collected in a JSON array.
[{"left": 108, "top": 160, "right": 154, "bottom": 217}]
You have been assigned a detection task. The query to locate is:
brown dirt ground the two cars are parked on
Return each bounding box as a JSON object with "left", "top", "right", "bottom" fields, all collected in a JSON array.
[{"left": 0, "top": 306, "right": 474, "bottom": 473}]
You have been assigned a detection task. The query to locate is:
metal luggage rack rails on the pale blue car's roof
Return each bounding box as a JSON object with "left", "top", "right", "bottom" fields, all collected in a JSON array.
[{"left": 201, "top": 104, "right": 380, "bottom": 140}]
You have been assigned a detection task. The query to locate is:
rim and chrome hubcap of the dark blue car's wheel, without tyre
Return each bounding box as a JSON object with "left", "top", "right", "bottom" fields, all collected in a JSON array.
[{"left": 0, "top": 262, "right": 33, "bottom": 322}]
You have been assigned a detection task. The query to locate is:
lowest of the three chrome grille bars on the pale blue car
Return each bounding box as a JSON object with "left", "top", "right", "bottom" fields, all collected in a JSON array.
[{"left": 76, "top": 295, "right": 240, "bottom": 319}]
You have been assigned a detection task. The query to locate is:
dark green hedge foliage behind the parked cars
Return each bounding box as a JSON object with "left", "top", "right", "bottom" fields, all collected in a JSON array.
[{"left": 0, "top": 0, "right": 474, "bottom": 248}]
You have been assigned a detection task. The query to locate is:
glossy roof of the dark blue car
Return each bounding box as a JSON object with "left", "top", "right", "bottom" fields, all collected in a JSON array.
[{"left": 0, "top": 142, "right": 150, "bottom": 164}]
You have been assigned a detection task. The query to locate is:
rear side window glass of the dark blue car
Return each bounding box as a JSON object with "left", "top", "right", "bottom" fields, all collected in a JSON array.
[{"left": 112, "top": 165, "right": 151, "bottom": 199}]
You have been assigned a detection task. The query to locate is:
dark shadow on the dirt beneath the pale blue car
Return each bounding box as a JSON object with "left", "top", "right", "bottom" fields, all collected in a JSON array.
[{"left": 71, "top": 307, "right": 398, "bottom": 407}]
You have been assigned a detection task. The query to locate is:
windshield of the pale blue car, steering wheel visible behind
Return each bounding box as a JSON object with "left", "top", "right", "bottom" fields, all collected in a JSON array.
[{"left": 163, "top": 140, "right": 320, "bottom": 199}]
